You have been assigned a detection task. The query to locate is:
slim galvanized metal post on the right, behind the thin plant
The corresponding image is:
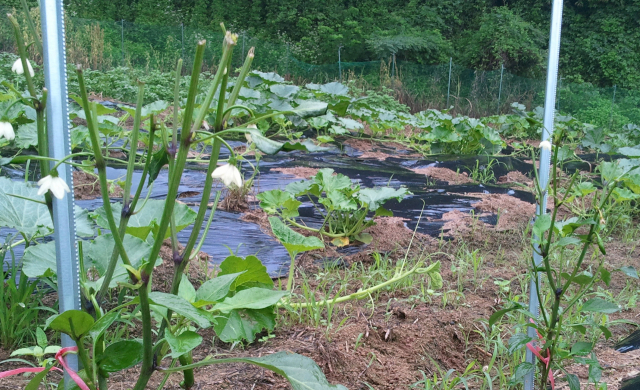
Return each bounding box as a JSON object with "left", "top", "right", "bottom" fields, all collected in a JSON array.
[{"left": 524, "top": 0, "right": 562, "bottom": 390}]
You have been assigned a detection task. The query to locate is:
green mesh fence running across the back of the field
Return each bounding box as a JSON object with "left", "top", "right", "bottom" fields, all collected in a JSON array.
[{"left": 0, "top": 9, "right": 640, "bottom": 127}]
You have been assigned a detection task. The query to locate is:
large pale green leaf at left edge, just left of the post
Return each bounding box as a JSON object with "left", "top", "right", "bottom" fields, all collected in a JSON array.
[{"left": 0, "top": 177, "right": 53, "bottom": 239}]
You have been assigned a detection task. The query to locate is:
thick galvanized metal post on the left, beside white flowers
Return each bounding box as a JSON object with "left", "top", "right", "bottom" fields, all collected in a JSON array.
[{"left": 40, "top": 0, "right": 81, "bottom": 388}]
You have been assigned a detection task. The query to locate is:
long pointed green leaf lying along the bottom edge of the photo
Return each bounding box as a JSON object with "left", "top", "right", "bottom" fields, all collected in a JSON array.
[{"left": 239, "top": 352, "right": 347, "bottom": 390}]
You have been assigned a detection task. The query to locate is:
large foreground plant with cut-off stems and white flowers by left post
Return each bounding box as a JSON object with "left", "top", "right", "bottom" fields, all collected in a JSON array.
[{"left": 0, "top": 13, "right": 344, "bottom": 390}]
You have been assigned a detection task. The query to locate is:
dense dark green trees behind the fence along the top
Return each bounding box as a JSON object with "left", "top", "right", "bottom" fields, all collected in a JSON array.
[{"left": 7, "top": 0, "right": 640, "bottom": 87}]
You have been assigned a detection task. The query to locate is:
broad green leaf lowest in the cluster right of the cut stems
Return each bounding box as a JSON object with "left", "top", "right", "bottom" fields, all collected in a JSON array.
[{"left": 214, "top": 307, "right": 276, "bottom": 343}]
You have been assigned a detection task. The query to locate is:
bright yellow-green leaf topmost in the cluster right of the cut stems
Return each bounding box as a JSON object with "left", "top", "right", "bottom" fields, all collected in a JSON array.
[{"left": 218, "top": 256, "right": 273, "bottom": 291}]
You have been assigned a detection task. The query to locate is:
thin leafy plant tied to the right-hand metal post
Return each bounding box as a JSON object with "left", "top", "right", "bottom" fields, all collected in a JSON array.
[{"left": 489, "top": 135, "right": 640, "bottom": 390}]
